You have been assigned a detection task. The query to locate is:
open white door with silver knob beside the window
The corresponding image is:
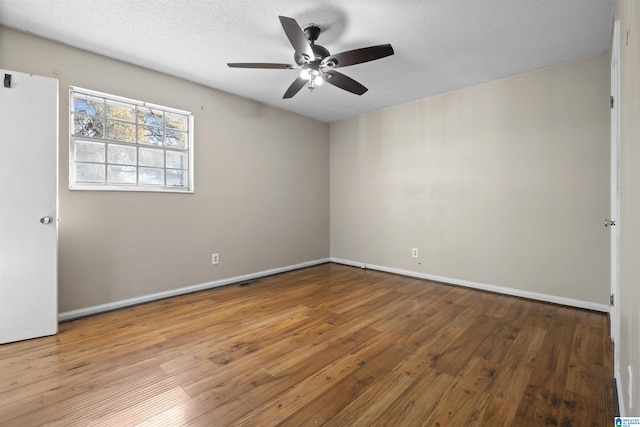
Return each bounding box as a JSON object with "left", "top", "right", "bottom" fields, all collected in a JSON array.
[{"left": 0, "top": 69, "right": 58, "bottom": 343}]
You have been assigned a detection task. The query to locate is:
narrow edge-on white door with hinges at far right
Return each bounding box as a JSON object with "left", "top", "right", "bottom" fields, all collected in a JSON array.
[{"left": 605, "top": 21, "right": 621, "bottom": 372}]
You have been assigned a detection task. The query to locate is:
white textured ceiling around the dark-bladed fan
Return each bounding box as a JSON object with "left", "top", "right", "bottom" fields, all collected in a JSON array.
[{"left": 0, "top": 0, "right": 614, "bottom": 122}]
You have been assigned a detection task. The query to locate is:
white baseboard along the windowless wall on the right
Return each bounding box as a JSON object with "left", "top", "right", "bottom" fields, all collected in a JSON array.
[{"left": 330, "top": 257, "right": 609, "bottom": 313}]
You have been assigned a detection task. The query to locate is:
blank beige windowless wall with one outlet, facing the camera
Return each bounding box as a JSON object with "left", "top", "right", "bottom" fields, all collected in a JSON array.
[{"left": 330, "top": 53, "right": 610, "bottom": 307}]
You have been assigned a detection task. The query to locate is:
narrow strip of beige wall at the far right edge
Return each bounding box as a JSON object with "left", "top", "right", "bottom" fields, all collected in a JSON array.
[{"left": 615, "top": 0, "right": 640, "bottom": 416}]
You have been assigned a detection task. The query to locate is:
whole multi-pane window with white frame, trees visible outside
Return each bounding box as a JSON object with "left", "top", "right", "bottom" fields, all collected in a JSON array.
[{"left": 69, "top": 88, "right": 193, "bottom": 192}]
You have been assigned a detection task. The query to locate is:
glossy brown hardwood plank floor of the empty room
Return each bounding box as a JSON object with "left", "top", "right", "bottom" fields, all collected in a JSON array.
[{"left": 0, "top": 264, "right": 613, "bottom": 427}]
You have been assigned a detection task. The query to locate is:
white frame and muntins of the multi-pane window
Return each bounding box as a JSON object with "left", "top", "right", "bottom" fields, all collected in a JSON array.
[{"left": 69, "top": 86, "right": 194, "bottom": 193}]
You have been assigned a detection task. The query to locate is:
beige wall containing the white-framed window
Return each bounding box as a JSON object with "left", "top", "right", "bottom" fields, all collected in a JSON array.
[{"left": 0, "top": 27, "right": 329, "bottom": 312}]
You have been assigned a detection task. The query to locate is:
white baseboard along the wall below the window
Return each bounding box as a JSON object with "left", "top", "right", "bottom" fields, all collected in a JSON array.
[{"left": 58, "top": 258, "right": 329, "bottom": 322}]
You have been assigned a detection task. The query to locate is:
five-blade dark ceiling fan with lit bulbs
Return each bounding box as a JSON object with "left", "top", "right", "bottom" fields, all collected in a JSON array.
[{"left": 227, "top": 16, "right": 393, "bottom": 99}]
